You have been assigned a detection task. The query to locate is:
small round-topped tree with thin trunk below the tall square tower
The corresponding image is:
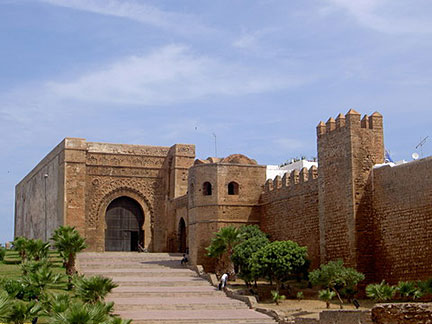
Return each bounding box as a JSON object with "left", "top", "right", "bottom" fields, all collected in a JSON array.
[{"left": 309, "top": 260, "right": 365, "bottom": 308}]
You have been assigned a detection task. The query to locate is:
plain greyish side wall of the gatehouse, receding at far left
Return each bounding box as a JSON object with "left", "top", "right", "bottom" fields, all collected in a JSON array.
[{"left": 15, "top": 139, "right": 68, "bottom": 241}]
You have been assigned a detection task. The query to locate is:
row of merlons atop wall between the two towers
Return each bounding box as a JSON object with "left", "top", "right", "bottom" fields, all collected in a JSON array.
[{"left": 264, "top": 166, "right": 318, "bottom": 192}]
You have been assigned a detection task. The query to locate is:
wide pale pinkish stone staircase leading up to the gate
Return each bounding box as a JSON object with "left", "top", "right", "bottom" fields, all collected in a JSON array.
[{"left": 78, "top": 252, "right": 276, "bottom": 324}]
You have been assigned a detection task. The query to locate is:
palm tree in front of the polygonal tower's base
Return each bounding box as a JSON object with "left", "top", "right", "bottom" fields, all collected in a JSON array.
[{"left": 206, "top": 226, "right": 241, "bottom": 276}]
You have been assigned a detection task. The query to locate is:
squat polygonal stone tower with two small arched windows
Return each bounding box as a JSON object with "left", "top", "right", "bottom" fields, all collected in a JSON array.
[{"left": 188, "top": 154, "right": 266, "bottom": 271}]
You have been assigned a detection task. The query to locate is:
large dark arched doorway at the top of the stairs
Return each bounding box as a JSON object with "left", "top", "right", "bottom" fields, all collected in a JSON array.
[{"left": 105, "top": 197, "right": 144, "bottom": 251}]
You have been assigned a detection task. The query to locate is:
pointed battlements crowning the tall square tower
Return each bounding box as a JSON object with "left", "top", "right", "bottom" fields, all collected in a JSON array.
[{"left": 317, "top": 109, "right": 383, "bottom": 137}]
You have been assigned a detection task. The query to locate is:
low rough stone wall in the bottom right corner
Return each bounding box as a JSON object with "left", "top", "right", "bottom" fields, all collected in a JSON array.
[{"left": 372, "top": 303, "right": 432, "bottom": 324}]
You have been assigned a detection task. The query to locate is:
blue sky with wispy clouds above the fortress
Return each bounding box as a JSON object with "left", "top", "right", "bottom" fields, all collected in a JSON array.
[{"left": 0, "top": 0, "right": 432, "bottom": 242}]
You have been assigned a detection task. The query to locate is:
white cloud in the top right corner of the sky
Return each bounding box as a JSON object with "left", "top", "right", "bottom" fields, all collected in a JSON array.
[{"left": 321, "top": 0, "right": 432, "bottom": 34}]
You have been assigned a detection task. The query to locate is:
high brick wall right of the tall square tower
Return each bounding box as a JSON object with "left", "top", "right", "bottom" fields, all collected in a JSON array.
[{"left": 371, "top": 158, "right": 432, "bottom": 283}]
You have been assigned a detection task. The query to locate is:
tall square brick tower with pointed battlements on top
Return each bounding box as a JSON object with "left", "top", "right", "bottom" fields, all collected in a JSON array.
[{"left": 317, "top": 109, "right": 384, "bottom": 270}]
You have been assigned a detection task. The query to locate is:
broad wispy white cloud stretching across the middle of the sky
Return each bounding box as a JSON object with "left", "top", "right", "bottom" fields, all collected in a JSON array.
[{"left": 45, "top": 45, "right": 307, "bottom": 106}]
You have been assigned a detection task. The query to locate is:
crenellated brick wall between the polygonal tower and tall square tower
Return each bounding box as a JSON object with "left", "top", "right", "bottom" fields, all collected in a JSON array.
[{"left": 261, "top": 166, "right": 320, "bottom": 268}]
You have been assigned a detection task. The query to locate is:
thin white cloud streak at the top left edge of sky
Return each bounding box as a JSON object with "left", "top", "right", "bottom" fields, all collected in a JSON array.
[{"left": 39, "top": 0, "right": 210, "bottom": 34}]
